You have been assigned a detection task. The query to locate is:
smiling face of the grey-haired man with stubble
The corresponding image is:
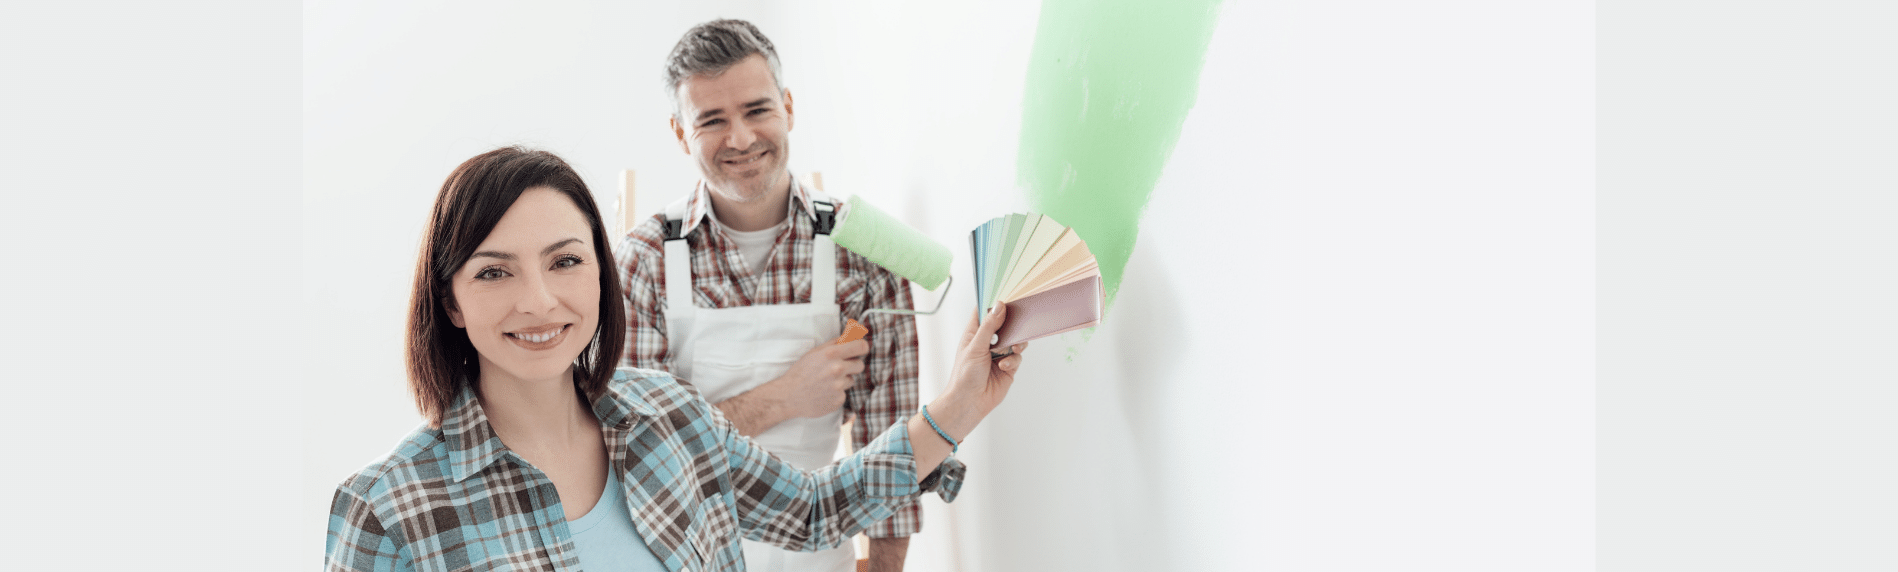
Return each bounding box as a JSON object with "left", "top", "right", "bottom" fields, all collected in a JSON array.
[{"left": 672, "top": 53, "right": 793, "bottom": 203}]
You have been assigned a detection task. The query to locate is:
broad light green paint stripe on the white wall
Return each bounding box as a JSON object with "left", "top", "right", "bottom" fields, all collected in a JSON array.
[{"left": 1015, "top": 0, "right": 1220, "bottom": 306}]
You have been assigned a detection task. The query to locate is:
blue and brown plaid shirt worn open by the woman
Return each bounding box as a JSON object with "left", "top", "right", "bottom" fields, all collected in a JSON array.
[{"left": 325, "top": 369, "right": 964, "bottom": 572}]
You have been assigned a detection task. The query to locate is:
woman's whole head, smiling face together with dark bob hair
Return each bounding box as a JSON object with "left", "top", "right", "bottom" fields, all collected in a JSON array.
[{"left": 408, "top": 146, "right": 626, "bottom": 428}]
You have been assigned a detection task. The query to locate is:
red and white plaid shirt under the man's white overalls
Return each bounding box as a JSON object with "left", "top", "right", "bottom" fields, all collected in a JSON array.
[{"left": 613, "top": 179, "right": 922, "bottom": 538}]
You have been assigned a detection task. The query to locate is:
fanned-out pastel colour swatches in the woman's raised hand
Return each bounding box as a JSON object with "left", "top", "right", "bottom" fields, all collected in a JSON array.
[{"left": 968, "top": 213, "right": 1107, "bottom": 348}]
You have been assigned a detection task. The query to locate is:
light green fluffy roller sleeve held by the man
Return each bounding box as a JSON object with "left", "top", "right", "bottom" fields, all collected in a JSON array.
[{"left": 831, "top": 196, "right": 955, "bottom": 291}]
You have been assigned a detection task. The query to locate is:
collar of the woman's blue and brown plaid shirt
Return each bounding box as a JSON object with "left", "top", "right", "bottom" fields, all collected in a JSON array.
[{"left": 442, "top": 371, "right": 659, "bottom": 483}]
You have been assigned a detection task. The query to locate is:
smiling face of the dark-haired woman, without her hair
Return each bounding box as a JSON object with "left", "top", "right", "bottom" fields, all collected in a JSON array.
[{"left": 448, "top": 186, "right": 604, "bottom": 382}]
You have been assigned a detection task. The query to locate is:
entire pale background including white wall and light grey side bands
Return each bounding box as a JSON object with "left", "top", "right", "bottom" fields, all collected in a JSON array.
[{"left": 0, "top": 2, "right": 1898, "bottom": 570}]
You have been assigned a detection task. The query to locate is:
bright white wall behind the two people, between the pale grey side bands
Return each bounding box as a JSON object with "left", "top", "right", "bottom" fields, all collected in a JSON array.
[{"left": 304, "top": 2, "right": 1594, "bottom": 570}]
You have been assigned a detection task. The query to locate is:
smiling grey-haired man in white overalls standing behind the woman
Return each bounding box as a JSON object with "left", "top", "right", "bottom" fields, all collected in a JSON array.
[{"left": 617, "top": 19, "right": 922, "bottom": 572}]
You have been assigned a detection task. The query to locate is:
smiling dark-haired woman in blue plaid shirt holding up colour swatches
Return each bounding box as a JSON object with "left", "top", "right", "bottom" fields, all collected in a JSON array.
[{"left": 325, "top": 148, "right": 1025, "bottom": 570}]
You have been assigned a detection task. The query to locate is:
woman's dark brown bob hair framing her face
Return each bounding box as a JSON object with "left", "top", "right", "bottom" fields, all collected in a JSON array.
[{"left": 408, "top": 146, "right": 626, "bottom": 428}]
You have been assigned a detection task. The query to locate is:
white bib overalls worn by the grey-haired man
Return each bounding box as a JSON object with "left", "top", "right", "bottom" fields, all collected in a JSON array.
[{"left": 666, "top": 192, "right": 856, "bottom": 572}]
